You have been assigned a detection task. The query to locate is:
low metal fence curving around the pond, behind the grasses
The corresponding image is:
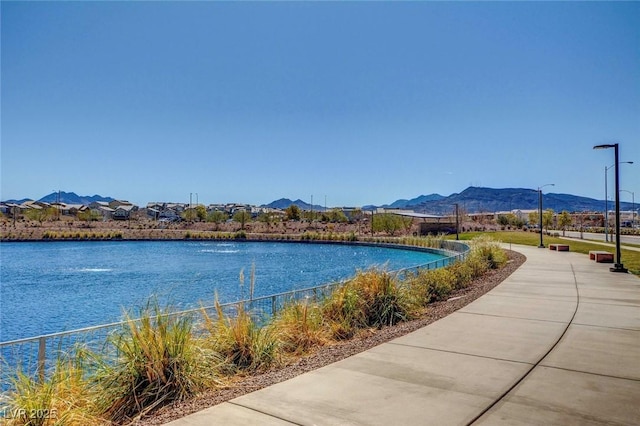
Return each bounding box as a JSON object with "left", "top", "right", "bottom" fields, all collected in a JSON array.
[{"left": 0, "top": 241, "right": 469, "bottom": 391}]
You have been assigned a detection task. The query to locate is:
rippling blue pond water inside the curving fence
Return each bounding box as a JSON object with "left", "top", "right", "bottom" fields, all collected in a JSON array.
[{"left": 0, "top": 241, "right": 442, "bottom": 342}]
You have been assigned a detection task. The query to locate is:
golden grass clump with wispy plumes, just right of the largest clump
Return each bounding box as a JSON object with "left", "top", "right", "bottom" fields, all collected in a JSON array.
[{"left": 202, "top": 300, "right": 279, "bottom": 374}]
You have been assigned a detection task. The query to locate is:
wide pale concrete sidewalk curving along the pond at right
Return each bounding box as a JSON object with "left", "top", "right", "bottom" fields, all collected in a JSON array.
[{"left": 169, "top": 246, "right": 640, "bottom": 426}]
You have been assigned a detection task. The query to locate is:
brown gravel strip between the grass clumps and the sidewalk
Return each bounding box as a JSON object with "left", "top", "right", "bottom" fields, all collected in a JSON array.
[{"left": 132, "top": 251, "right": 526, "bottom": 426}]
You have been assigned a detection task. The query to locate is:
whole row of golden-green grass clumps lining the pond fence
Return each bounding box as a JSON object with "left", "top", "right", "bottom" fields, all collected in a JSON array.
[{"left": 0, "top": 238, "right": 508, "bottom": 425}]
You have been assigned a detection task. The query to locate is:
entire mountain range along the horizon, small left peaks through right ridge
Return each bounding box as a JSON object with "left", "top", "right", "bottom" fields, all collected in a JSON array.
[{"left": 3, "top": 186, "right": 636, "bottom": 214}]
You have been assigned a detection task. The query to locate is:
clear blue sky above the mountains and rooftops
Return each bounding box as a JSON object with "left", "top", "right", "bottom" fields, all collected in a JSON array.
[{"left": 0, "top": 1, "right": 640, "bottom": 206}]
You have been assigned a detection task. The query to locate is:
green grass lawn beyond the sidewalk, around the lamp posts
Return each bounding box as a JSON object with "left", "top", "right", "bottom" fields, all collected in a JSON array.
[{"left": 449, "top": 231, "right": 640, "bottom": 275}]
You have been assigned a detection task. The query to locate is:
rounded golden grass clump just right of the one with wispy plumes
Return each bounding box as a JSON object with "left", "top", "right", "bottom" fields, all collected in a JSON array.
[{"left": 273, "top": 301, "right": 331, "bottom": 355}]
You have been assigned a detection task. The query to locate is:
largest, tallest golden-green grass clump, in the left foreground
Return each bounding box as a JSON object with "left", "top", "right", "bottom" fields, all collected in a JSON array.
[{"left": 96, "top": 301, "right": 221, "bottom": 423}]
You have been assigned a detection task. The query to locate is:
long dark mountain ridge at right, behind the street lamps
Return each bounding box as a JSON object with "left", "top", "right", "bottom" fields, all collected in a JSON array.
[{"left": 405, "top": 186, "right": 633, "bottom": 214}]
